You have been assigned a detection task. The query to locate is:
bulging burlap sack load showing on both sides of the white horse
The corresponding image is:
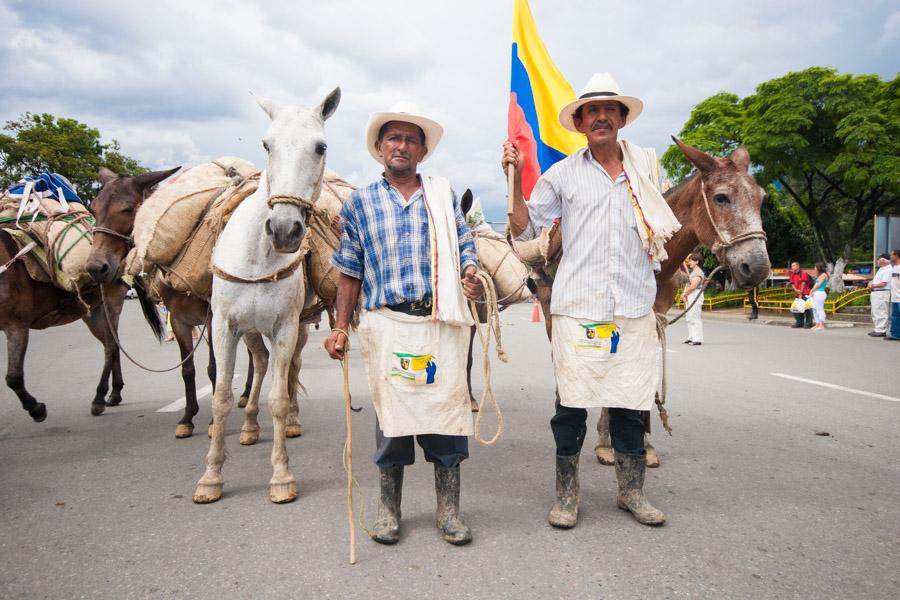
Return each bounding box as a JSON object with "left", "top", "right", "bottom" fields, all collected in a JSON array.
[{"left": 126, "top": 157, "right": 354, "bottom": 304}]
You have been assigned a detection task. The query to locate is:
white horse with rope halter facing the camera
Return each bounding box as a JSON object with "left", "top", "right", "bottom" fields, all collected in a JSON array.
[{"left": 193, "top": 88, "right": 341, "bottom": 504}]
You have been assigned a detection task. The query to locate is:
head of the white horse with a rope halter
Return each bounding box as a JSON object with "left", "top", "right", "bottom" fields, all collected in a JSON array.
[{"left": 256, "top": 88, "right": 341, "bottom": 253}]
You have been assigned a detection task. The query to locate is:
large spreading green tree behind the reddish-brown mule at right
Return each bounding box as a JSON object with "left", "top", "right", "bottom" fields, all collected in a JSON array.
[{"left": 662, "top": 67, "right": 900, "bottom": 291}]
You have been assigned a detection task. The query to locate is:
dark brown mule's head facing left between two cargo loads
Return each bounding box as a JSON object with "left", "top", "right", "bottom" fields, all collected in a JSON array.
[{"left": 85, "top": 167, "right": 180, "bottom": 283}]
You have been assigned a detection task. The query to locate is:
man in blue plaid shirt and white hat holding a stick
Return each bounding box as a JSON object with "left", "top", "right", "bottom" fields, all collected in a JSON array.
[{"left": 325, "top": 103, "right": 483, "bottom": 545}]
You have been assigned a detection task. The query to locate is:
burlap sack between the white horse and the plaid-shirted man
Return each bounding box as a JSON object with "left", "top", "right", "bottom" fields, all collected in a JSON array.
[{"left": 306, "top": 169, "right": 356, "bottom": 304}]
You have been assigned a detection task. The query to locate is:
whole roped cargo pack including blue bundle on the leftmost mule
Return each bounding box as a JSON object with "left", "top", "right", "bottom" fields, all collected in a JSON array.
[{"left": 0, "top": 171, "right": 94, "bottom": 294}]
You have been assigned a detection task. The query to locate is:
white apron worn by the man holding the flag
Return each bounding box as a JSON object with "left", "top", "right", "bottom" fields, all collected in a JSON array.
[{"left": 552, "top": 311, "right": 660, "bottom": 410}]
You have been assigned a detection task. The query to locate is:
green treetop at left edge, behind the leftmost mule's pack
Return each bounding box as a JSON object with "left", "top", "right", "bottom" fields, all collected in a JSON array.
[{"left": 0, "top": 113, "right": 147, "bottom": 202}]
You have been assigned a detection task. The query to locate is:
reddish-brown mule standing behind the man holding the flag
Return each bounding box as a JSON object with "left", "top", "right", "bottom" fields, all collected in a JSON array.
[{"left": 538, "top": 138, "right": 772, "bottom": 466}]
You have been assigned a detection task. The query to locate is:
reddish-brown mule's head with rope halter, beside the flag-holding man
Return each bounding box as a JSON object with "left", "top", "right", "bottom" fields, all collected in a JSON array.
[{"left": 672, "top": 138, "right": 772, "bottom": 289}]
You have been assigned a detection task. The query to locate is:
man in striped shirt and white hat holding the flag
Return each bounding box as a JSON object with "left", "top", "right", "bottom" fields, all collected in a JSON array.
[{"left": 502, "top": 75, "right": 665, "bottom": 528}]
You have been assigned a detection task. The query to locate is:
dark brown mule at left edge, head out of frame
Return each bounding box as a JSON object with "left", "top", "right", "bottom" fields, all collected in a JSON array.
[{"left": 0, "top": 199, "right": 163, "bottom": 423}]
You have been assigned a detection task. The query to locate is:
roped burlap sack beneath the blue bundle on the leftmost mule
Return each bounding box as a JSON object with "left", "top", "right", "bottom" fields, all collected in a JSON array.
[{"left": 0, "top": 194, "right": 94, "bottom": 293}]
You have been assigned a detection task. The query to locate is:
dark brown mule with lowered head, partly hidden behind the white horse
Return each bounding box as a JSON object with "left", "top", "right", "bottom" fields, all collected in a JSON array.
[{"left": 87, "top": 167, "right": 253, "bottom": 438}]
